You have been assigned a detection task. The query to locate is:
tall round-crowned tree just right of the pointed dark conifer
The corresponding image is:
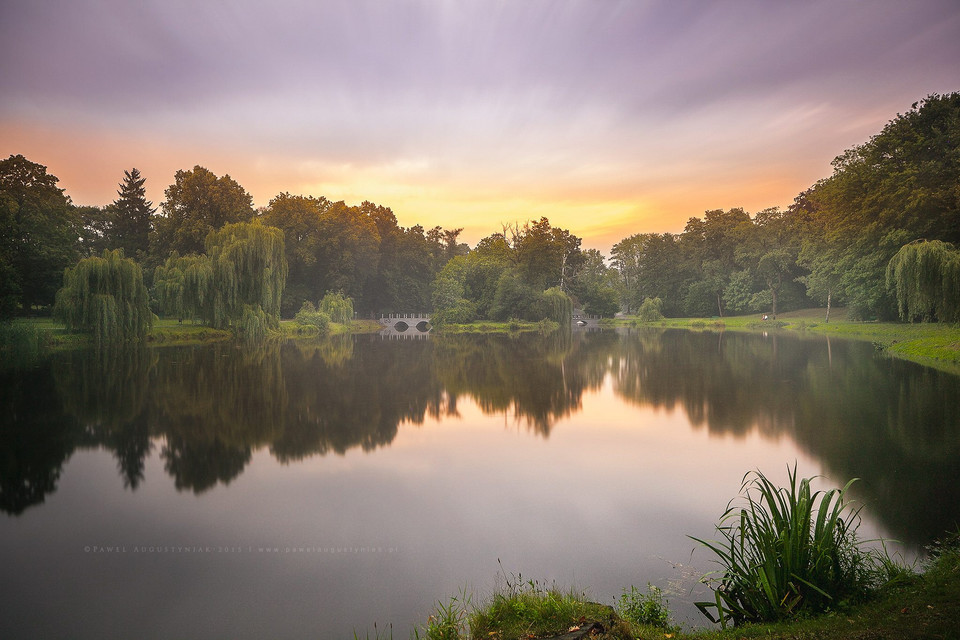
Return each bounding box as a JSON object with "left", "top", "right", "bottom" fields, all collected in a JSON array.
[{"left": 152, "top": 166, "right": 254, "bottom": 259}]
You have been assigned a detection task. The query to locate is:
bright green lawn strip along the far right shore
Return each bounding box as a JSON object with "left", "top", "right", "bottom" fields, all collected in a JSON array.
[{"left": 603, "top": 309, "right": 960, "bottom": 373}]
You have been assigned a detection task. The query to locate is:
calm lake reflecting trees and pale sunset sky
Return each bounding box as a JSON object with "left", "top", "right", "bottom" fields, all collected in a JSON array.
[{"left": 0, "top": 330, "right": 960, "bottom": 638}]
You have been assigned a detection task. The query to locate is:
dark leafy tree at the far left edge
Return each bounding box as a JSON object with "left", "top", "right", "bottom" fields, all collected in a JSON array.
[{"left": 0, "top": 155, "right": 80, "bottom": 317}]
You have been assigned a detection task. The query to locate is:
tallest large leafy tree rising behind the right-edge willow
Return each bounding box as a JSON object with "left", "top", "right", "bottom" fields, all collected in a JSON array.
[{"left": 798, "top": 93, "right": 960, "bottom": 317}]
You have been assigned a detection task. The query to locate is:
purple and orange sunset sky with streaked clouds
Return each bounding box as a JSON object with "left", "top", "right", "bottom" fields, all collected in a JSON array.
[{"left": 0, "top": 0, "right": 960, "bottom": 255}]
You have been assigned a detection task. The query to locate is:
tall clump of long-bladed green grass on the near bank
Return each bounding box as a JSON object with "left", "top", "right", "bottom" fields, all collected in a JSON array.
[{"left": 693, "top": 466, "right": 881, "bottom": 627}]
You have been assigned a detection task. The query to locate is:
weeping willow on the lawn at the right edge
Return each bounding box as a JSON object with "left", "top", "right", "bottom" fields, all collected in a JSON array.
[{"left": 887, "top": 240, "right": 960, "bottom": 322}]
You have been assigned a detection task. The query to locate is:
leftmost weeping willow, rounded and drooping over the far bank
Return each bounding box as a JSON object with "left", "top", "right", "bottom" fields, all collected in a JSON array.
[{"left": 53, "top": 249, "right": 153, "bottom": 345}]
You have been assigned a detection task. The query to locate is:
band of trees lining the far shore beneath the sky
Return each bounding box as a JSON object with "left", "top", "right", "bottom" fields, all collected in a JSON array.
[{"left": 0, "top": 93, "right": 960, "bottom": 338}]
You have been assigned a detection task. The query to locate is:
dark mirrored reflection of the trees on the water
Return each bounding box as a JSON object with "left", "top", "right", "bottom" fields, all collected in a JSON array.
[{"left": 0, "top": 330, "right": 960, "bottom": 544}]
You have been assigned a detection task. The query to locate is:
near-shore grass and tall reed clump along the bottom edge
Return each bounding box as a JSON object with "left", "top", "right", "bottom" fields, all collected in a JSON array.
[{"left": 384, "top": 470, "right": 960, "bottom": 640}]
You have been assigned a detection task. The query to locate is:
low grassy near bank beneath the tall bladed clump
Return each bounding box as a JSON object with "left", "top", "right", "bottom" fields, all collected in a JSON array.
[{"left": 392, "top": 536, "right": 960, "bottom": 640}]
